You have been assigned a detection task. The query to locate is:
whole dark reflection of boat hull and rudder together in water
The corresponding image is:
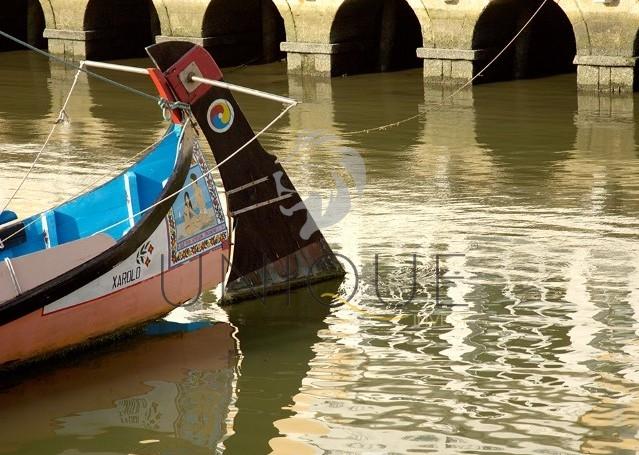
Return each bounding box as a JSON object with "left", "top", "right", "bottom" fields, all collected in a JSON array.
[{"left": 0, "top": 283, "right": 339, "bottom": 455}]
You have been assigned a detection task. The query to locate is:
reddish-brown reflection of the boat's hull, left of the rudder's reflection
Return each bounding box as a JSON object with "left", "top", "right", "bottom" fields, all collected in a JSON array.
[{"left": 0, "top": 321, "right": 238, "bottom": 454}]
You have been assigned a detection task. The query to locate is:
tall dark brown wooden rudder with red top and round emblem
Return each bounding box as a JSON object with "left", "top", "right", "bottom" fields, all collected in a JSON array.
[{"left": 147, "top": 41, "right": 344, "bottom": 302}]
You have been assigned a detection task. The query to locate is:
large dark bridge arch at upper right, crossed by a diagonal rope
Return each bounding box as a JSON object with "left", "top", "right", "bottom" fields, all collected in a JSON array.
[{"left": 472, "top": 0, "right": 577, "bottom": 81}]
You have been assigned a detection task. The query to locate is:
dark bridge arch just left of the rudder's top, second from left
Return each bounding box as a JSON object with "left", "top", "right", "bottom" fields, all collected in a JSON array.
[{"left": 83, "top": 0, "right": 160, "bottom": 60}]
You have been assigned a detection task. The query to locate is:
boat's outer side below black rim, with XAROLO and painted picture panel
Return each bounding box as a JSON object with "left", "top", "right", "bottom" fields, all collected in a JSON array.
[{"left": 0, "top": 142, "right": 230, "bottom": 367}]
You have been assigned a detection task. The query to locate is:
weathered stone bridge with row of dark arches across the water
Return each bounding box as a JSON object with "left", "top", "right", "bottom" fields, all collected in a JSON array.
[{"left": 0, "top": 0, "right": 639, "bottom": 93}]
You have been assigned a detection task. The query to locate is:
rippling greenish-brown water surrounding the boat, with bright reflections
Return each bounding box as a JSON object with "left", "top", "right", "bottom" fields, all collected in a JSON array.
[{"left": 0, "top": 52, "right": 639, "bottom": 455}]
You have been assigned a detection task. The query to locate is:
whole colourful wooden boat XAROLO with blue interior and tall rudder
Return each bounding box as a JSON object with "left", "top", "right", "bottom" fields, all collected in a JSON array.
[{"left": 0, "top": 42, "right": 344, "bottom": 365}]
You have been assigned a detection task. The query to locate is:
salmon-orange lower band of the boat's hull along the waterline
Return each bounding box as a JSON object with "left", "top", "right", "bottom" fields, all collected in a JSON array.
[{"left": 0, "top": 247, "right": 229, "bottom": 365}]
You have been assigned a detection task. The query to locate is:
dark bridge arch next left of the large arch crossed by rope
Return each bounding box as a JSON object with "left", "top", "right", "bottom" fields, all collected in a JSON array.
[{"left": 330, "top": 0, "right": 424, "bottom": 76}]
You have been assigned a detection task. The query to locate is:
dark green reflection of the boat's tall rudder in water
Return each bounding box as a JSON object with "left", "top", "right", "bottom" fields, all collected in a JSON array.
[{"left": 224, "top": 280, "right": 341, "bottom": 455}]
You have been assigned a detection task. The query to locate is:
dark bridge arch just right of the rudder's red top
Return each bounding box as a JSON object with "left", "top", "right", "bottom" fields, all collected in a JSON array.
[{"left": 202, "top": 0, "right": 286, "bottom": 66}]
